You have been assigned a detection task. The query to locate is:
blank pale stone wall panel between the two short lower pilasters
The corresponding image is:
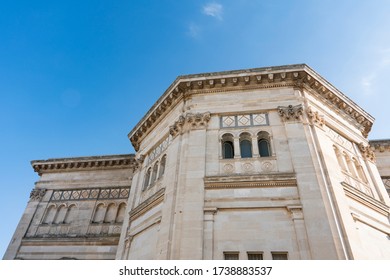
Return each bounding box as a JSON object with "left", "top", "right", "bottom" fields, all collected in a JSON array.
[{"left": 209, "top": 208, "right": 300, "bottom": 260}]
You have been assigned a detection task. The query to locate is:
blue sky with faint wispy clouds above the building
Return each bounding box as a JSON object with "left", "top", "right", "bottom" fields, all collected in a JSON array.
[{"left": 0, "top": 0, "right": 390, "bottom": 257}]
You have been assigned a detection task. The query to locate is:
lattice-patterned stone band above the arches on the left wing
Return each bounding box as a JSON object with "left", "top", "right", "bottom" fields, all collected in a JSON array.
[{"left": 50, "top": 187, "right": 130, "bottom": 201}]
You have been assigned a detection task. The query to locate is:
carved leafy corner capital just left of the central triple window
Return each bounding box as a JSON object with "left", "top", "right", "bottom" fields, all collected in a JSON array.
[{"left": 169, "top": 112, "right": 211, "bottom": 137}]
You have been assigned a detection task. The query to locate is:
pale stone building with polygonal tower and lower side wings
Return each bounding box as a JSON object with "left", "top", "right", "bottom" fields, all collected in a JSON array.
[{"left": 4, "top": 65, "right": 390, "bottom": 260}]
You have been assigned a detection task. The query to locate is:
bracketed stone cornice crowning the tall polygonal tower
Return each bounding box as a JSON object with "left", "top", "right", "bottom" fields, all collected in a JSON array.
[{"left": 128, "top": 64, "right": 374, "bottom": 151}]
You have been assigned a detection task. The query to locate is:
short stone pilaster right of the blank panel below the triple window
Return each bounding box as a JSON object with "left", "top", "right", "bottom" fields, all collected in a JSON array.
[{"left": 287, "top": 205, "right": 311, "bottom": 260}]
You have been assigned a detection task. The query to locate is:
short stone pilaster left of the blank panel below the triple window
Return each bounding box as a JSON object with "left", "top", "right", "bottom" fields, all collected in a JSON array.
[{"left": 203, "top": 208, "right": 218, "bottom": 260}]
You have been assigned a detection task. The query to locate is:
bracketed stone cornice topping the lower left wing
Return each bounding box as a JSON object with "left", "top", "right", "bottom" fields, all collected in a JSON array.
[{"left": 31, "top": 154, "right": 136, "bottom": 175}]
